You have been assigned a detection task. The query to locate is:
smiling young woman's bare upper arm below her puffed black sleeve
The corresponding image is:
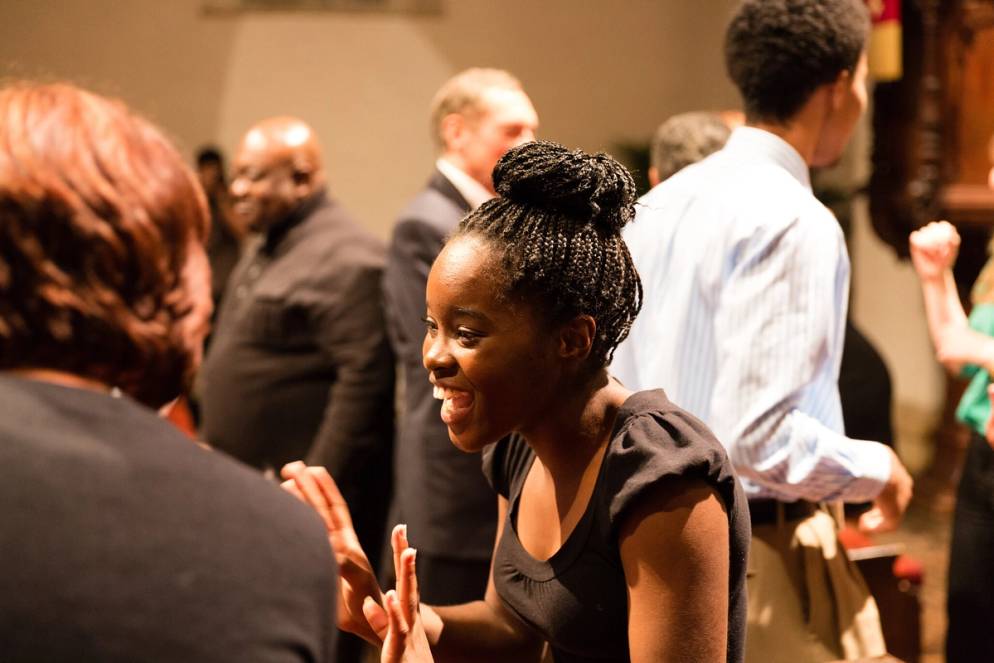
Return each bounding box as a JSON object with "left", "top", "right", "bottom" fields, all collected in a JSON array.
[{"left": 618, "top": 480, "right": 730, "bottom": 663}]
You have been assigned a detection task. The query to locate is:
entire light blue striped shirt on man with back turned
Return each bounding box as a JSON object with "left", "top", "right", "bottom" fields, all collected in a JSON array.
[{"left": 611, "top": 127, "right": 890, "bottom": 501}]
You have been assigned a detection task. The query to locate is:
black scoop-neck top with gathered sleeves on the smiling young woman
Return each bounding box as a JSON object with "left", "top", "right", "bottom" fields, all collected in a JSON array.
[{"left": 483, "top": 390, "right": 750, "bottom": 663}]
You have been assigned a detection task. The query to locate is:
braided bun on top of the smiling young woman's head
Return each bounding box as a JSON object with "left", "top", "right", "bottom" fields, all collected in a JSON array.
[{"left": 493, "top": 141, "right": 635, "bottom": 233}]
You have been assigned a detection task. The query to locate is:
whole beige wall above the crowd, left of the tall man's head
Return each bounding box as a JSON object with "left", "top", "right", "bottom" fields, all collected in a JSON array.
[{"left": 0, "top": 0, "right": 736, "bottom": 236}]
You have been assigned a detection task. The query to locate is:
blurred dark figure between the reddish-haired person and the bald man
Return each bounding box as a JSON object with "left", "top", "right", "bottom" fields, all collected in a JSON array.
[{"left": 197, "top": 145, "right": 247, "bottom": 322}]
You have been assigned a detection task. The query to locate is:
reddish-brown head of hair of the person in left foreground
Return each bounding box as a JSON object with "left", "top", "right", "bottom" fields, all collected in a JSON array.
[{"left": 0, "top": 83, "right": 209, "bottom": 407}]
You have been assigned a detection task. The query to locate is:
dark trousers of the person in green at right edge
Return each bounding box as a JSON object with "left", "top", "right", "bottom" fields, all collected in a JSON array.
[{"left": 946, "top": 433, "right": 994, "bottom": 663}]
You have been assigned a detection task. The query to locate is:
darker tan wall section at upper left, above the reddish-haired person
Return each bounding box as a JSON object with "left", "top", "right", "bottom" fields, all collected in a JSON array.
[{"left": 0, "top": 0, "right": 235, "bottom": 158}]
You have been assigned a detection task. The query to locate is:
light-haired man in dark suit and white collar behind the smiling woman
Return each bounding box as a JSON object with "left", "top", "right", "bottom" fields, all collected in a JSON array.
[{"left": 383, "top": 68, "right": 538, "bottom": 605}]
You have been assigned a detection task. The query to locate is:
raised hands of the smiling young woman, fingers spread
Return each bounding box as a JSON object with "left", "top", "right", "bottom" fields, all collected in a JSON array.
[{"left": 281, "top": 462, "right": 433, "bottom": 663}]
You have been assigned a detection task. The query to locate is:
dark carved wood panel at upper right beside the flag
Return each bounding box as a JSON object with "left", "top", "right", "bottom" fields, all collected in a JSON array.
[{"left": 870, "top": 0, "right": 994, "bottom": 254}]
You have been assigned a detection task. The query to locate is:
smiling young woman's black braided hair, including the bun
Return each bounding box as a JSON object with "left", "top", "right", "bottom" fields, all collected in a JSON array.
[{"left": 456, "top": 141, "right": 642, "bottom": 368}]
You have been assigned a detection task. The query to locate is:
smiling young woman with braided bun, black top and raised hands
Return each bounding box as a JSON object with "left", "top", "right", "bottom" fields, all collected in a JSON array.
[{"left": 285, "top": 142, "right": 749, "bottom": 661}]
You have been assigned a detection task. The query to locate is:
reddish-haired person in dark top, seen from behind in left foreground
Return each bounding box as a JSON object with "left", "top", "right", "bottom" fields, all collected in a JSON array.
[{"left": 0, "top": 83, "right": 334, "bottom": 661}]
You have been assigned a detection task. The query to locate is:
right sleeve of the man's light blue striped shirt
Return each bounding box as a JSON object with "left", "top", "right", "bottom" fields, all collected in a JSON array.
[{"left": 711, "top": 218, "right": 891, "bottom": 501}]
